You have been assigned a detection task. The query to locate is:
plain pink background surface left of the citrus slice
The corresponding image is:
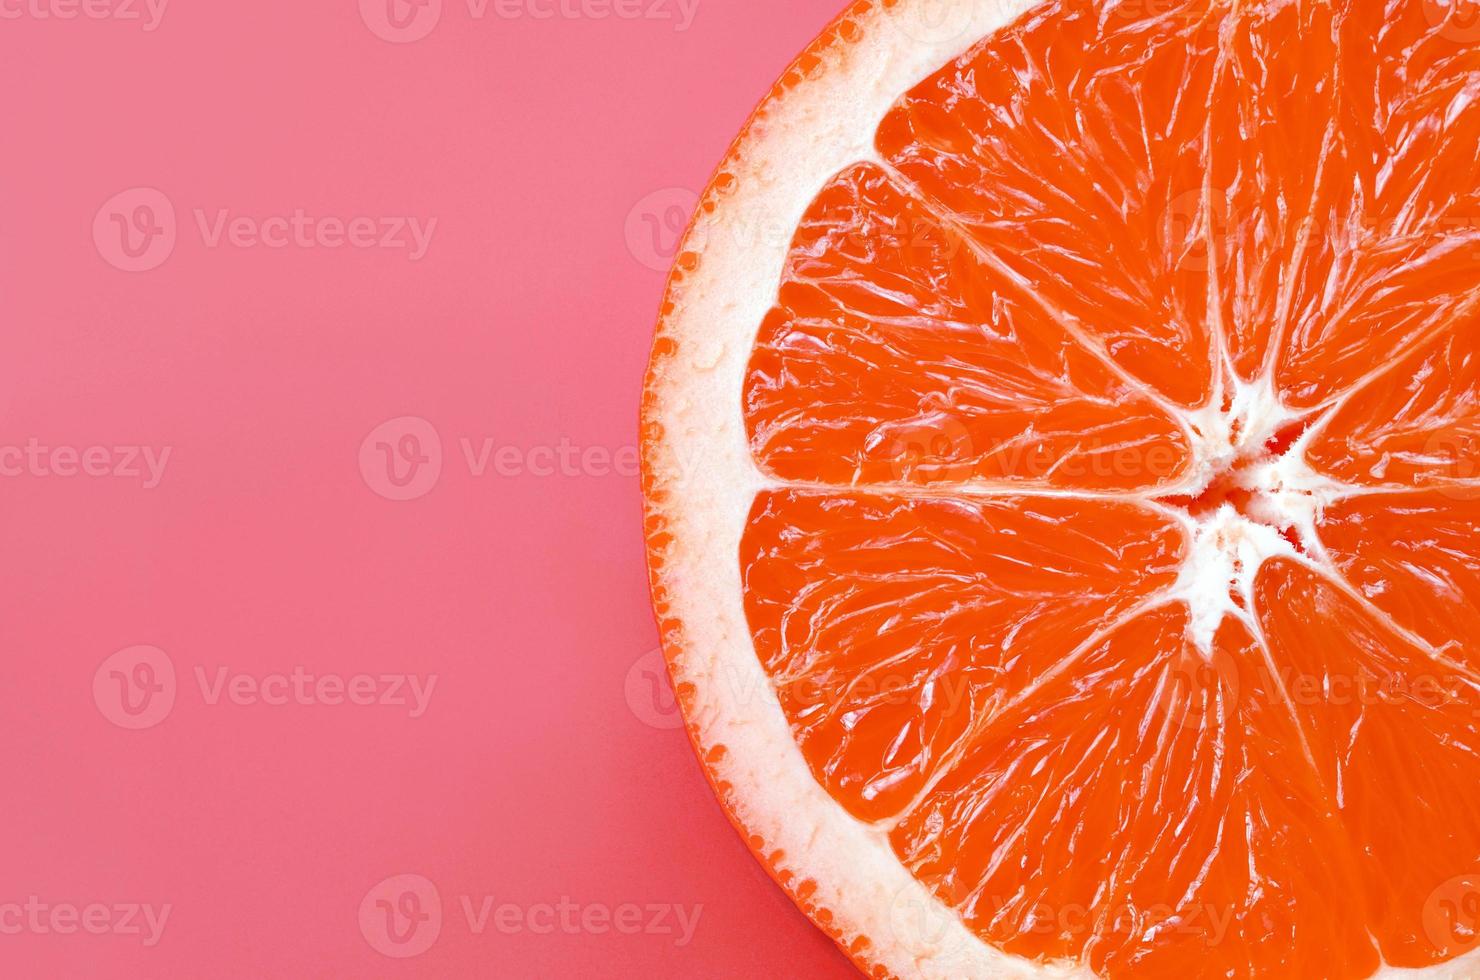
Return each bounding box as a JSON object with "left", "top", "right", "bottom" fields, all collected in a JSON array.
[{"left": 0, "top": 0, "right": 852, "bottom": 979}]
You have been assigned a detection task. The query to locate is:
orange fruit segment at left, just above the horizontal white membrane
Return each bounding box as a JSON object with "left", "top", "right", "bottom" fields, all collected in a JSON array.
[{"left": 746, "top": 164, "right": 1190, "bottom": 490}]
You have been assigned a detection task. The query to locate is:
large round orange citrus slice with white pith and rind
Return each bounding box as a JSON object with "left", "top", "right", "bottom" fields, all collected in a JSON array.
[{"left": 642, "top": 0, "right": 1480, "bottom": 980}]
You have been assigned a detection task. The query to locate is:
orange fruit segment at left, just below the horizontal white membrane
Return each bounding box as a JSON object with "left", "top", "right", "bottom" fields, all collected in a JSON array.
[{"left": 741, "top": 491, "right": 1180, "bottom": 819}]
